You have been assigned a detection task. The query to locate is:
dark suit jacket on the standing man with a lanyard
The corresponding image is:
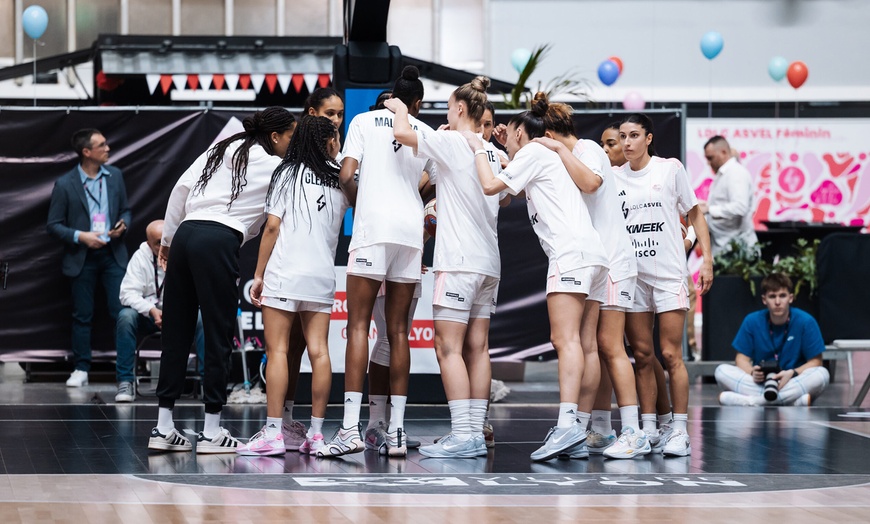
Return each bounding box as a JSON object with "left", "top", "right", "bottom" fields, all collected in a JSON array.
[{"left": 46, "top": 165, "right": 131, "bottom": 277}]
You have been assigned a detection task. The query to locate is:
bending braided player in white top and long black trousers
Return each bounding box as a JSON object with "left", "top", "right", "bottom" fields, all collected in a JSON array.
[{"left": 148, "top": 107, "right": 296, "bottom": 453}]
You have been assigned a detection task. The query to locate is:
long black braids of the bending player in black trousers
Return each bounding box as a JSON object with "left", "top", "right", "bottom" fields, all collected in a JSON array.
[{"left": 193, "top": 107, "right": 296, "bottom": 210}]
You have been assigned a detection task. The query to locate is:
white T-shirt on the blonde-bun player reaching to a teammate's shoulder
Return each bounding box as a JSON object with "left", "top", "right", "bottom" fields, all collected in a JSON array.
[{"left": 417, "top": 131, "right": 501, "bottom": 278}]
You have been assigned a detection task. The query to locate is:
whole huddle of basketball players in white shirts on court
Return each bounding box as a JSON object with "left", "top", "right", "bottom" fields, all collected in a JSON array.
[{"left": 149, "top": 67, "right": 712, "bottom": 461}]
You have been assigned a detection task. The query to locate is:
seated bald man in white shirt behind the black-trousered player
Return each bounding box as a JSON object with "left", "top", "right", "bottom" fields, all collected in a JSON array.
[{"left": 115, "top": 220, "right": 205, "bottom": 402}]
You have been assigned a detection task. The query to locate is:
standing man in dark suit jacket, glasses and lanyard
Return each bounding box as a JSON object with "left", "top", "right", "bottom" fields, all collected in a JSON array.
[{"left": 47, "top": 129, "right": 130, "bottom": 387}]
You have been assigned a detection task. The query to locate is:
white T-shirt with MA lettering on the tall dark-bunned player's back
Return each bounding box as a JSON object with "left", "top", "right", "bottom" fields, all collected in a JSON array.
[{"left": 342, "top": 109, "right": 433, "bottom": 251}]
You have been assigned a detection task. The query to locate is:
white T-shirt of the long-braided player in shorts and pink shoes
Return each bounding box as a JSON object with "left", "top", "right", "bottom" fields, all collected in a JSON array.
[{"left": 263, "top": 166, "right": 348, "bottom": 304}]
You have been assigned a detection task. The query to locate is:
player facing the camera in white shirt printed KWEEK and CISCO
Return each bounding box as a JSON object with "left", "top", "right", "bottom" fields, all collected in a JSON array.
[{"left": 615, "top": 114, "right": 713, "bottom": 456}]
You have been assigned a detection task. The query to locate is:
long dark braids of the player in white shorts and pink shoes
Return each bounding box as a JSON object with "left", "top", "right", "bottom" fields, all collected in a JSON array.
[{"left": 266, "top": 115, "right": 339, "bottom": 228}]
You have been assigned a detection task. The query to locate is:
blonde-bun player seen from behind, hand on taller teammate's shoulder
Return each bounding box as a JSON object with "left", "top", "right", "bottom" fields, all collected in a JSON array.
[{"left": 385, "top": 77, "right": 501, "bottom": 458}]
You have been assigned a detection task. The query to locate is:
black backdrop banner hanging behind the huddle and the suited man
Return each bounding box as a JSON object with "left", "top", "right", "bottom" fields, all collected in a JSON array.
[{"left": 0, "top": 108, "right": 683, "bottom": 361}]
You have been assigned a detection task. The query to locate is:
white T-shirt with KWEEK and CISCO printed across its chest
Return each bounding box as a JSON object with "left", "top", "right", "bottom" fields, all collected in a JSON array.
[{"left": 614, "top": 156, "right": 698, "bottom": 293}]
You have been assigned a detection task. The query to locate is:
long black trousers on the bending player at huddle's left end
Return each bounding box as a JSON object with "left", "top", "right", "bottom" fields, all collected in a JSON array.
[{"left": 157, "top": 220, "right": 242, "bottom": 413}]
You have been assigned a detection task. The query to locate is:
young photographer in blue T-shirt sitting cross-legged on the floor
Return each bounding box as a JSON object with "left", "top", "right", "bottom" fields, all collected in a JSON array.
[{"left": 716, "top": 273, "right": 830, "bottom": 406}]
